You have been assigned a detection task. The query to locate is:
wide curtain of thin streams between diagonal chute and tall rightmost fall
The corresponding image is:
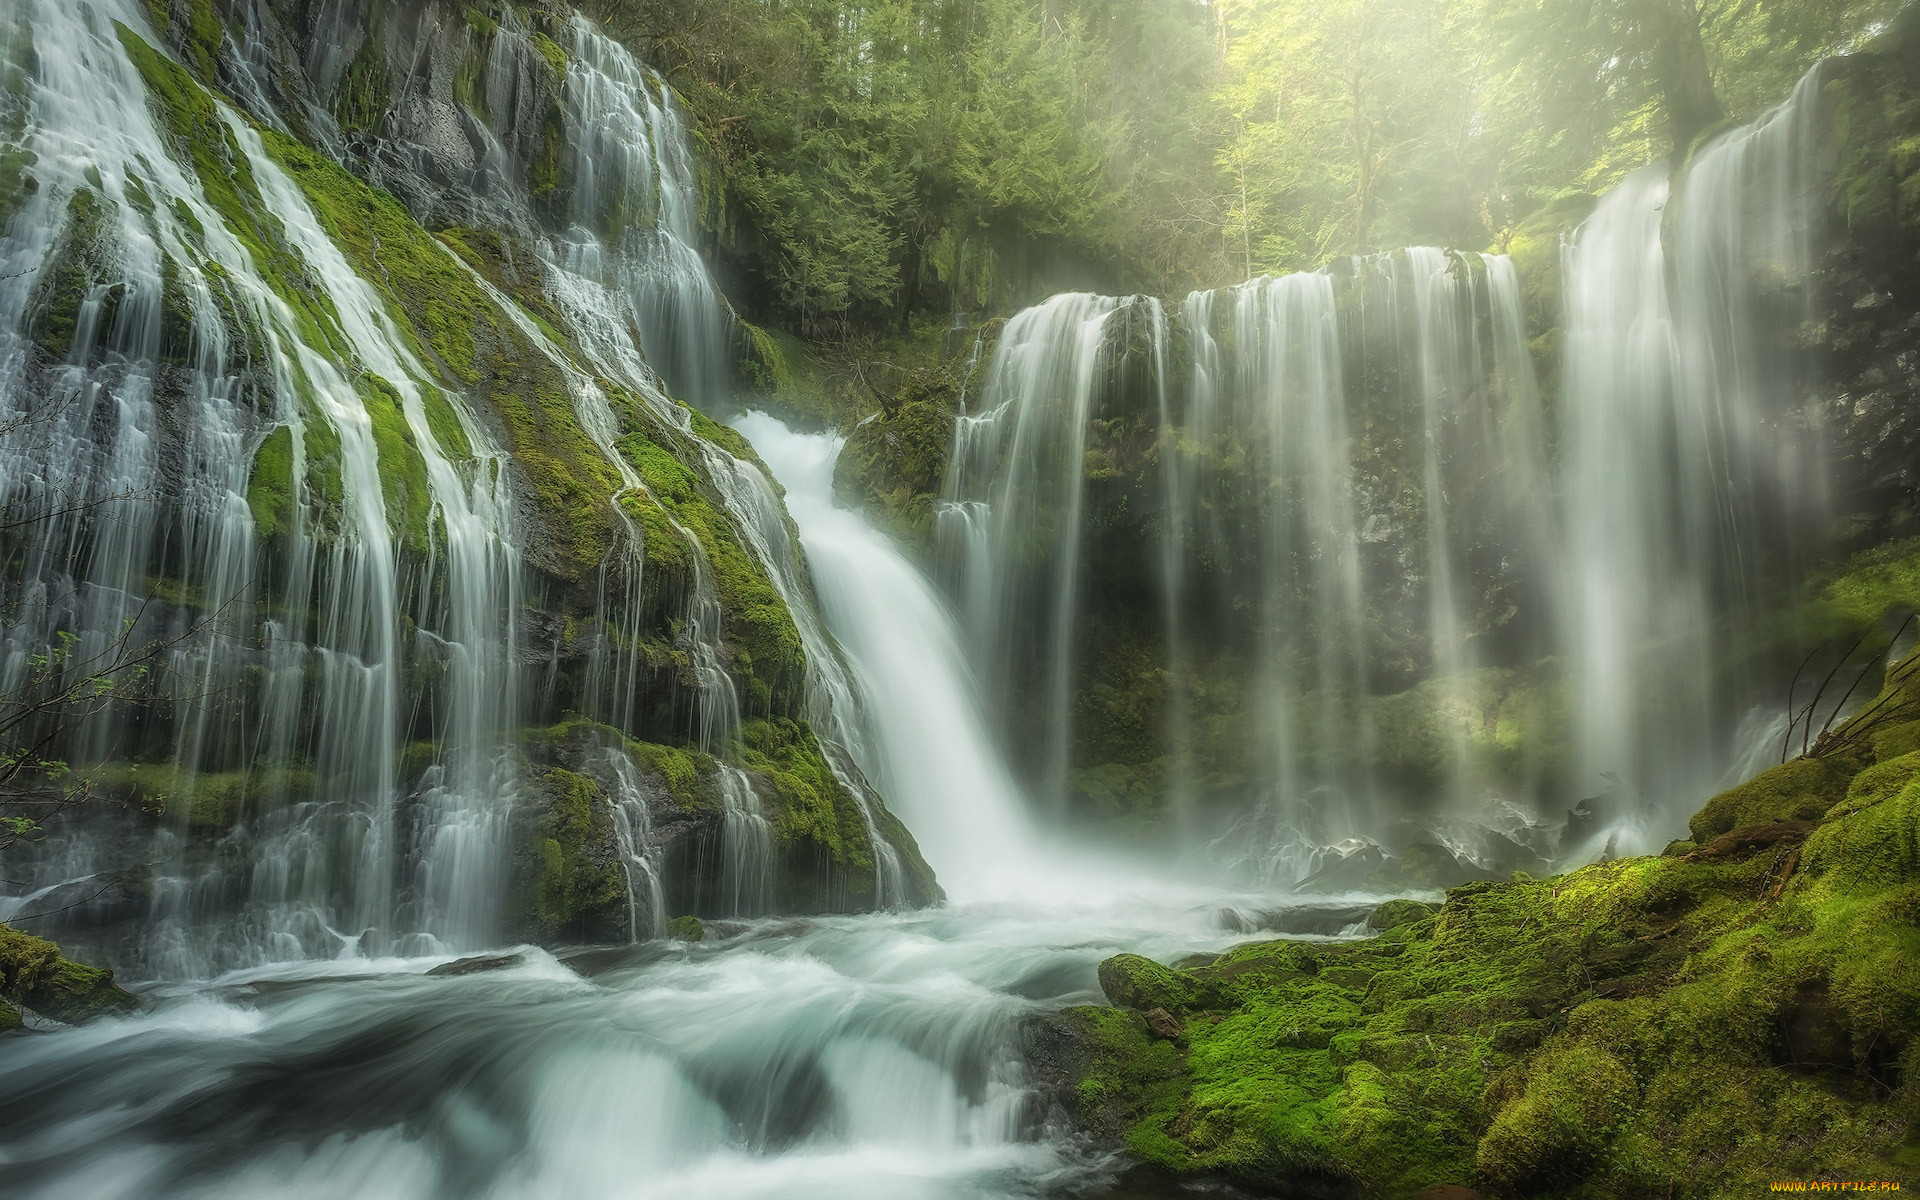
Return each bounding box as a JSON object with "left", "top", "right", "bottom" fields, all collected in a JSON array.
[{"left": 937, "top": 248, "right": 1557, "bottom": 877}]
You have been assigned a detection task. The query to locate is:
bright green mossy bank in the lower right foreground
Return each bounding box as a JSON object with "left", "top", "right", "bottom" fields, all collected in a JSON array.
[{"left": 1060, "top": 648, "right": 1920, "bottom": 1200}]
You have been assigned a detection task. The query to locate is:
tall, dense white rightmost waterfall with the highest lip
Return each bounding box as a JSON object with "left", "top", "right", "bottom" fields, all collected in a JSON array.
[{"left": 1563, "top": 67, "right": 1826, "bottom": 849}]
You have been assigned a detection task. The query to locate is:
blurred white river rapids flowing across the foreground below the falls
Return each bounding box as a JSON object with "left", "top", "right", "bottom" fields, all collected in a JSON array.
[{"left": 0, "top": 885, "right": 1363, "bottom": 1200}]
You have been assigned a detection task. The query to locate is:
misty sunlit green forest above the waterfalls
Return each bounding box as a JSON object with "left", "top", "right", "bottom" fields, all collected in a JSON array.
[{"left": 586, "top": 0, "right": 1899, "bottom": 340}]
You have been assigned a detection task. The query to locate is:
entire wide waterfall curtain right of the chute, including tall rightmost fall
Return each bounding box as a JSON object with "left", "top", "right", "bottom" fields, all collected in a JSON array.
[{"left": 937, "top": 58, "right": 1828, "bottom": 877}]
